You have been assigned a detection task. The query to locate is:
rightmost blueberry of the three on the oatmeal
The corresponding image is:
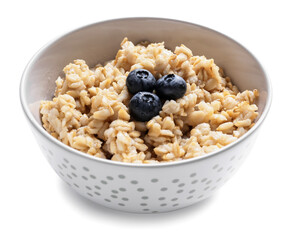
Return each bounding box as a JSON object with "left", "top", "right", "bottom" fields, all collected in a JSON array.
[{"left": 156, "top": 74, "right": 187, "bottom": 100}]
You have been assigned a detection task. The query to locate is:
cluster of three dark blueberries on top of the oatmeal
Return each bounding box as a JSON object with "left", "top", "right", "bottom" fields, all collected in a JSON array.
[{"left": 126, "top": 69, "right": 187, "bottom": 122}]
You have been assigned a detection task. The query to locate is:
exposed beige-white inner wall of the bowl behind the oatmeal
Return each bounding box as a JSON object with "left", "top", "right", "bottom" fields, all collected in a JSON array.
[{"left": 22, "top": 18, "right": 270, "bottom": 124}]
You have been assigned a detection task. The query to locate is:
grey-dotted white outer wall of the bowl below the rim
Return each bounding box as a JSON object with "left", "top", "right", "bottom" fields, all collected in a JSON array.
[{"left": 42, "top": 138, "right": 253, "bottom": 213}]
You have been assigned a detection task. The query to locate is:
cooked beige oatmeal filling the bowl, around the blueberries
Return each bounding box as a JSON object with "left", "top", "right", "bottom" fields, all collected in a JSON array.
[{"left": 40, "top": 38, "right": 259, "bottom": 163}]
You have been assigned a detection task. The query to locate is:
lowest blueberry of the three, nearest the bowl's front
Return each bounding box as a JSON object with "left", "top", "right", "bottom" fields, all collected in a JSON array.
[{"left": 129, "top": 92, "right": 162, "bottom": 122}]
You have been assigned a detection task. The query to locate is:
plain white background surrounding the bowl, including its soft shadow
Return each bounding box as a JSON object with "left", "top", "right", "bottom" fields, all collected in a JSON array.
[{"left": 0, "top": 0, "right": 291, "bottom": 240}]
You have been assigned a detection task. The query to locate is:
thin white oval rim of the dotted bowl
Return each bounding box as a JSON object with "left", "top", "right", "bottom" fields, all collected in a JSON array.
[{"left": 19, "top": 17, "right": 273, "bottom": 168}]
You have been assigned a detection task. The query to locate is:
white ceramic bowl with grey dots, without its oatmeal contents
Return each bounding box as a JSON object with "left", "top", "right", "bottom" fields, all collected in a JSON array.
[{"left": 20, "top": 18, "right": 271, "bottom": 213}]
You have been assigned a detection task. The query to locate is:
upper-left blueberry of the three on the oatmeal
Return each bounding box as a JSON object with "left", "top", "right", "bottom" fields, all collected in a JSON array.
[{"left": 126, "top": 69, "right": 156, "bottom": 94}]
